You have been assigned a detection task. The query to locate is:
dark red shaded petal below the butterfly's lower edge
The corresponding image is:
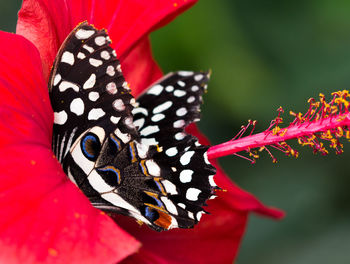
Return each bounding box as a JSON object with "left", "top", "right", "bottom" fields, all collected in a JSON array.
[{"left": 113, "top": 205, "right": 248, "bottom": 264}]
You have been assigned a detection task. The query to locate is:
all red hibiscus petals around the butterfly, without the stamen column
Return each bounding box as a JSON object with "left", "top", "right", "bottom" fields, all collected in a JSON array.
[{"left": 0, "top": 0, "right": 282, "bottom": 263}]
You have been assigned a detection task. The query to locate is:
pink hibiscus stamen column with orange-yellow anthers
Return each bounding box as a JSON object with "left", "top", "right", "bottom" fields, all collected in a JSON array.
[{"left": 208, "top": 90, "right": 350, "bottom": 163}]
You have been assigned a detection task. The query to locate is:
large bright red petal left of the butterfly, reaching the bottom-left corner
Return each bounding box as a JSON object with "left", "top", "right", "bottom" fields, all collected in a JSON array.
[{"left": 0, "top": 32, "right": 140, "bottom": 263}]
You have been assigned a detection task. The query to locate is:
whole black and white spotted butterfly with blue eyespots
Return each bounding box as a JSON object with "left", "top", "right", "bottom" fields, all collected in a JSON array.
[{"left": 49, "top": 22, "right": 218, "bottom": 231}]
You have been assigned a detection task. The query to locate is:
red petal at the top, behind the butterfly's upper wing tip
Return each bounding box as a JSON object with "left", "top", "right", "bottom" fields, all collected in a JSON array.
[{"left": 17, "top": 0, "right": 196, "bottom": 89}]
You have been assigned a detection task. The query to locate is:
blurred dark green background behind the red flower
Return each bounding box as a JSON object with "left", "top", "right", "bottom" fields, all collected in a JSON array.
[{"left": 0, "top": 0, "right": 350, "bottom": 264}]
